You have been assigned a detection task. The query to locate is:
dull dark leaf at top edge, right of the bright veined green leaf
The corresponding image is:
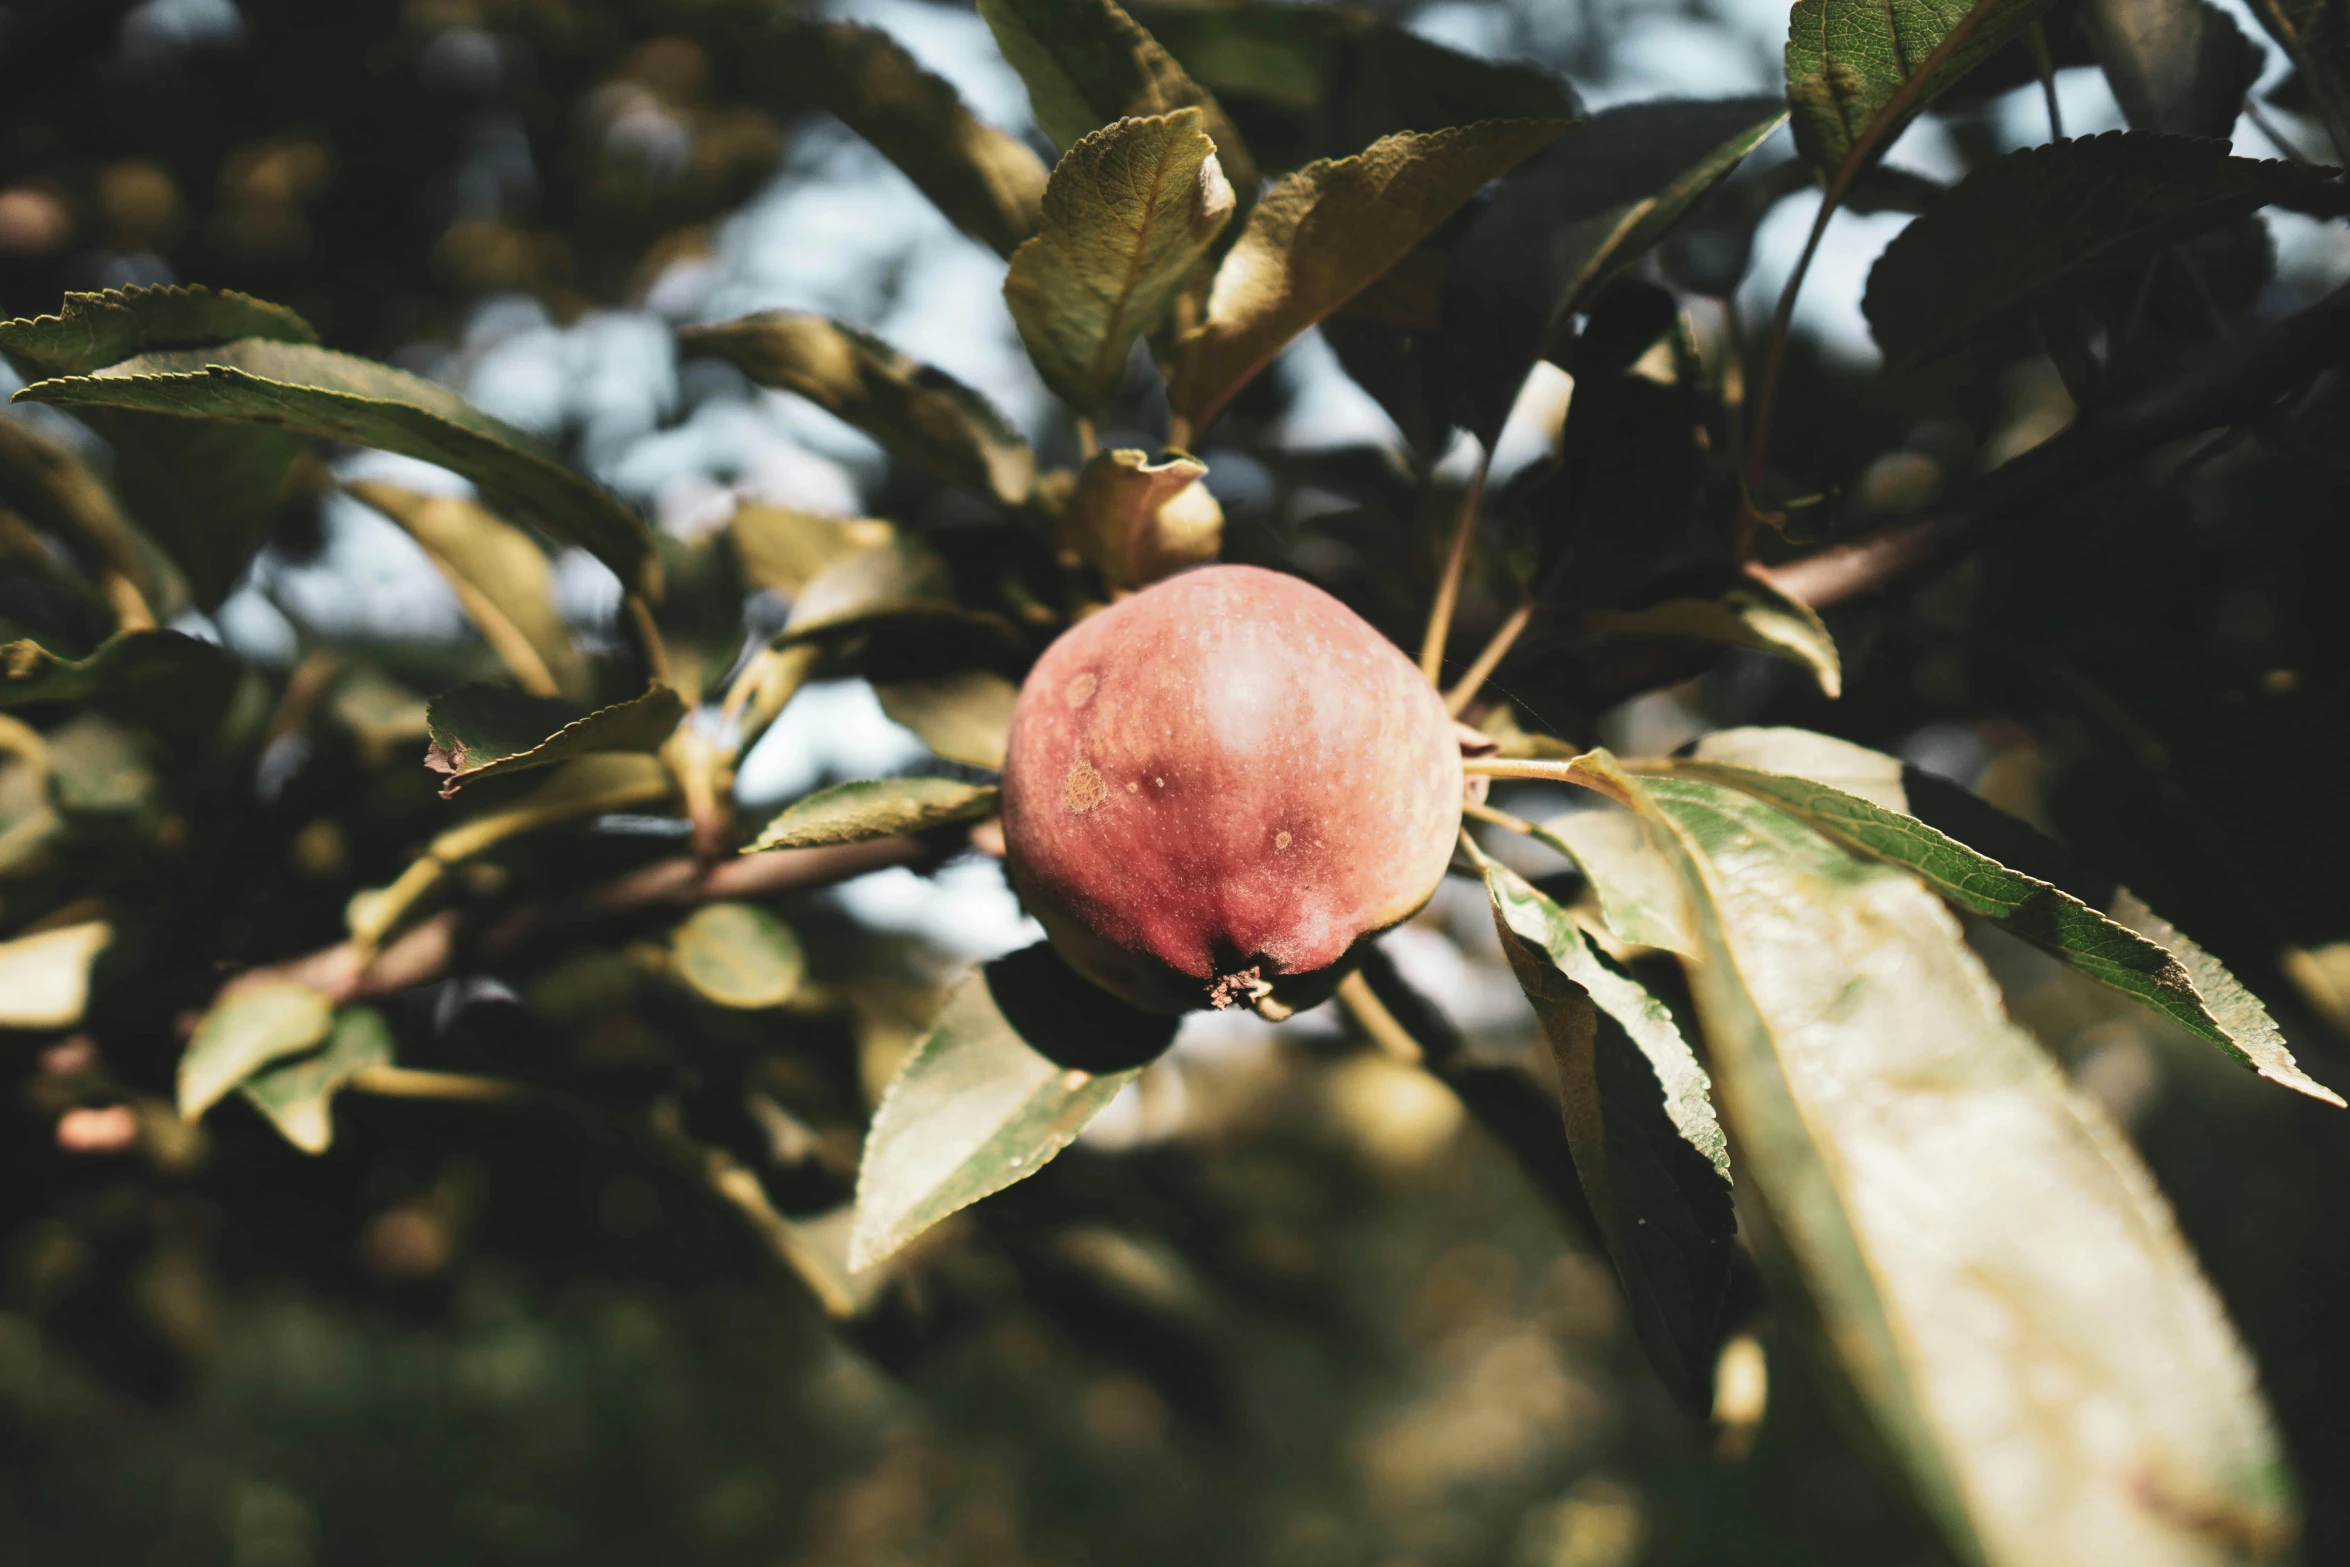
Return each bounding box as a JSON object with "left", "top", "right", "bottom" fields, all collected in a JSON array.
[{"left": 2080, "top": 0, "right": 2263, "bottom": 141}]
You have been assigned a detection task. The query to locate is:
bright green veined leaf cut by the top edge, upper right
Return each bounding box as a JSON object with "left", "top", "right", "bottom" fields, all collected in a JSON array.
[{"left": 1786, "top": 0, "right": 2049, "bottom": 184}]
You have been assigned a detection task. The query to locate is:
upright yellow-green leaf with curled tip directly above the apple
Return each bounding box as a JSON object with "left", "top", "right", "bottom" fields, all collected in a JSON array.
[{"left": 1003, "top": 108, "right": 1231, "bottom": 418}]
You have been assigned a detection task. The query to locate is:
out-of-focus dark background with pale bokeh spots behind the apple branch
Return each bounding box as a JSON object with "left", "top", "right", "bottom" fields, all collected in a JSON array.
[{"left": 0, "top": 0, "right": 2350, "bottom": 1567}]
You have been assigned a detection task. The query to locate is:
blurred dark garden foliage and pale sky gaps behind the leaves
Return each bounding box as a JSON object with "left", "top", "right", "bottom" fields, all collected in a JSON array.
[{"left": 0, "top": 0, "right": 2350, "bottom": 1567}]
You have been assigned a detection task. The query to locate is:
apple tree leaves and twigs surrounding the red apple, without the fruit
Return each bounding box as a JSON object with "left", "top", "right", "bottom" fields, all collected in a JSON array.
[{"left": 13, "top": 0, "right": 2350, "bottom": 1562}]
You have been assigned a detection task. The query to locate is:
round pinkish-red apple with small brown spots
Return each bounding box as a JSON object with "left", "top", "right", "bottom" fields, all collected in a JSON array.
[{"left": 1003, "top": 566, "right": 1462, "bottom": 1015}]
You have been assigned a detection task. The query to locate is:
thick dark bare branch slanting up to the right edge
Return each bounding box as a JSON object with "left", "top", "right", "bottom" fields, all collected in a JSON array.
[{"left": 1758, "top": 284, "right": 2350, "bottom": 608}]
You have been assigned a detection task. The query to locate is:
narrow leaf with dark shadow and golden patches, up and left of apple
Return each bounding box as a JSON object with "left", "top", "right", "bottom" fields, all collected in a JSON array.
[{"left": 677, "top": 310, "right": 1036, "bottom": 505}]
